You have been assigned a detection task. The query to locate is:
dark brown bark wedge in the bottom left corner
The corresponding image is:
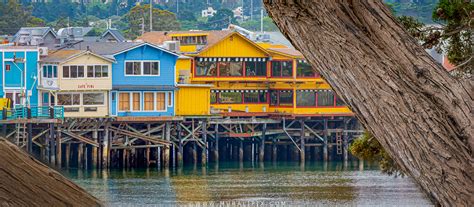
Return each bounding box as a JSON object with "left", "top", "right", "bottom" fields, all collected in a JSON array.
[{"left": 0, "top": 138, "right": 102, "bottom": 206}]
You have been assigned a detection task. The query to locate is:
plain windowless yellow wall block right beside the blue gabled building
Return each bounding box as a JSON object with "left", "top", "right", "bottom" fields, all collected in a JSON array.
[{"left": 175, "top": 85, "right": 211, "bottom": 116}]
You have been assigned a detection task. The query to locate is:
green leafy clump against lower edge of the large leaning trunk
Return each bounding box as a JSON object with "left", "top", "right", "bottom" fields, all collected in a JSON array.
[{"left": 349, "top": 132, "right": 404, "bottom": 176}]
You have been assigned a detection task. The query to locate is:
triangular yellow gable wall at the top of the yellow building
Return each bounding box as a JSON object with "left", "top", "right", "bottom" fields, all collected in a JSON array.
[{"left": 199, "top": 33, "right": 268, "bottom": 57}]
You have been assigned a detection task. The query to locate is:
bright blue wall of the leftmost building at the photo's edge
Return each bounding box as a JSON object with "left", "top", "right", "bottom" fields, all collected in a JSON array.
[{"left": 0, "top": 49, "right": 39, "bottom": 106}]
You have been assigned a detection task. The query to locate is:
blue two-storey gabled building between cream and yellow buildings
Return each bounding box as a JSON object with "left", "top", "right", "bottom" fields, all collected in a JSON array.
[{"left": 65, "top": 42, "right": 179, "bottom": 117}]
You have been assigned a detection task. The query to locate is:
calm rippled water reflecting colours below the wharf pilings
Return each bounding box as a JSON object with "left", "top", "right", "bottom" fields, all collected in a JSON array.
[{"left": 64, "top": 163, "right": 430, "bottom": 206}]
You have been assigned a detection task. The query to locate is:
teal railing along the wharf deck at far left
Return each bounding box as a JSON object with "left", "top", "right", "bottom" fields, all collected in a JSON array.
[{"left": 0, "top": 106, "right": 64, "bottom": 120}]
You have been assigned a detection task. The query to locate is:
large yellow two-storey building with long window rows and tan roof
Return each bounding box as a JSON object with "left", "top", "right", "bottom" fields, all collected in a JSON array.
[{"left": 139, "top": 30, "right": 352, "bottom": 116}]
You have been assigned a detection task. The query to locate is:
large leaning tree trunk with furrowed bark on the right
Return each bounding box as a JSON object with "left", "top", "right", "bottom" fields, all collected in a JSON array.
[{"left": 264, "top": 0, "right": 474, "bottom": 206}]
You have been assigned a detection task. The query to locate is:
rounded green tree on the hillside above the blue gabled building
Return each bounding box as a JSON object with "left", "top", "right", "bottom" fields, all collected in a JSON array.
[{"left": 125, "top": 4, "right": 180, "bottom": 39}]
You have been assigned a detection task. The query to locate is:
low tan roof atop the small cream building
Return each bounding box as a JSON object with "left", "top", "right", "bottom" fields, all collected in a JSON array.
[{"left": 41, "top": 50, "right": 114, "bottom": 63}]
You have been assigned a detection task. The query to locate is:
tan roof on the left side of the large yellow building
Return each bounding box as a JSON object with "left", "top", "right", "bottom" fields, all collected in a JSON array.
[{"left": 137, "top": 30, "right": 233, "bottom": 53}]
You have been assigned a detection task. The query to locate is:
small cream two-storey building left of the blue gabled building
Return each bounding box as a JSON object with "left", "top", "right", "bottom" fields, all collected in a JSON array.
[{"left": 38, "top": 50, "right": 113, "bottom": 117}]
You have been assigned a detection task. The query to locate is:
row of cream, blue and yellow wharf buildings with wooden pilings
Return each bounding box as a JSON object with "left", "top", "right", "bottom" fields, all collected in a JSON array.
[{"left": 0, "top": 27, "right": 361, "bottom": 168}]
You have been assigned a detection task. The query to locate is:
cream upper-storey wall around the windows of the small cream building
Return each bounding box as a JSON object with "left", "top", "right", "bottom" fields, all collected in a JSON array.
[{"left": 58, "top": 54, "right": 112, "bottom": 91}]
